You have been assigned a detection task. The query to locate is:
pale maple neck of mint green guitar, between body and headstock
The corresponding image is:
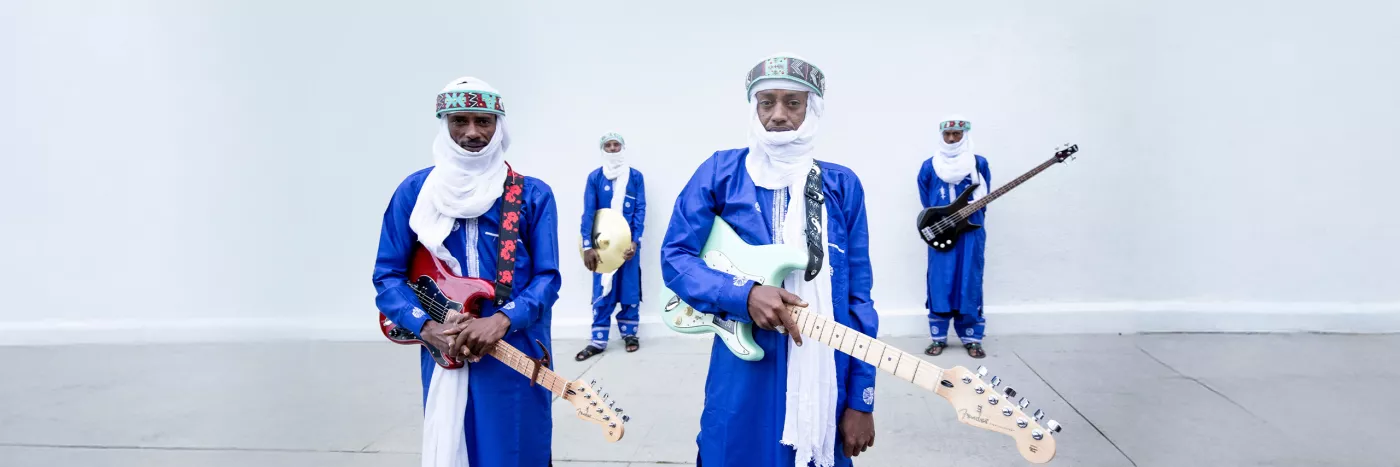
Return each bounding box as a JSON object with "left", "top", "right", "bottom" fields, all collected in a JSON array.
[{"left": 792, "top": 308, "right": 944, "bottom": 390}]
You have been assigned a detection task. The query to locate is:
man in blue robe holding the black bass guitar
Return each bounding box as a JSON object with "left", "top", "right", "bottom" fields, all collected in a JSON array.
[{"left": 918, "top": 116, "right": 991, "bottom": 358}]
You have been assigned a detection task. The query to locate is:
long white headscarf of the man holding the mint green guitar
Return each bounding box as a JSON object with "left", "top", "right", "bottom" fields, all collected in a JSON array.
[{"left": 745, "top": 55, "right": 837, "bottom": 467}]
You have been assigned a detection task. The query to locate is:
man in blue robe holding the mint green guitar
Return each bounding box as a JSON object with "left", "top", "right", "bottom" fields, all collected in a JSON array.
[{"left": 661, "top": 55, "right": 879, "bottom": 467}]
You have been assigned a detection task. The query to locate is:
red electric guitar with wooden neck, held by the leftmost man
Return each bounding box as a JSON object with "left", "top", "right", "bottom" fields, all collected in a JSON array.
[{"left": 379, "top": 245, "right": 630, "bottom": 442}]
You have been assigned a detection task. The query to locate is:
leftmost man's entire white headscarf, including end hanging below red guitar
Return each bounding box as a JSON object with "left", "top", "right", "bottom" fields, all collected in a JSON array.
[{"left": 409, "top": 77, "right": 511, "bottom": 467}]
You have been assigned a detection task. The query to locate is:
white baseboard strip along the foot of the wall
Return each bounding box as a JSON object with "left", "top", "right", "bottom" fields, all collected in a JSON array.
[{"left": 0, "top": 302, "right": 1400, "bottom": 345}]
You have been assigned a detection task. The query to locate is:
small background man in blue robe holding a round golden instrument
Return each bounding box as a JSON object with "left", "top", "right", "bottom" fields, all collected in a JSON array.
[{"left": 574, "top": 133, "right": 647, "bottom": 362}]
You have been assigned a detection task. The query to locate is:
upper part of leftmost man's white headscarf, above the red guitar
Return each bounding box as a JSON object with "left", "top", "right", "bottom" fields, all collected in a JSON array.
[{"left": 409, "top": 77, "right": 511, "bottom": 275}]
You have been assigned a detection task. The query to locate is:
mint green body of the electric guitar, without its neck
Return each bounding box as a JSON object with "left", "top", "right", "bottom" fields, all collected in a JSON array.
[{"left": 661, "top": 217, "right": 806, "bottom": 362}]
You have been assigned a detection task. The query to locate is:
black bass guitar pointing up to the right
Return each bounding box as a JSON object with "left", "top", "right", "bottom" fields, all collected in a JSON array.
[{"left": 917, "top": 144, "right": 1079, "bottom": 252}]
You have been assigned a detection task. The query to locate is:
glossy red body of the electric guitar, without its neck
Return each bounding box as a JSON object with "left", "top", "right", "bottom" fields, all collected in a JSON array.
[{"left": 379, "top": 246, "right": 496, "bottom": 369}]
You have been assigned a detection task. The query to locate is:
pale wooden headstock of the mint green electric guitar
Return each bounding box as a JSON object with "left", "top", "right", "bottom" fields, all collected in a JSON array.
[{"left": 934, "top": 366, "right": 1060, "bottom": 464}]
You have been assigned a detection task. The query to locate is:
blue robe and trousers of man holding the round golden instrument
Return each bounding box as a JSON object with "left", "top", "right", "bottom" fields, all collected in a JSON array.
[{"left": 578, "top": 168, "right": 647, "bottom": 347}]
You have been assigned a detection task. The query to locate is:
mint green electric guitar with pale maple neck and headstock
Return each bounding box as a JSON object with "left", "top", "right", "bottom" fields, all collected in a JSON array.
[{"left": 661, "top": 218, "right": 1060, "bottom": 464}]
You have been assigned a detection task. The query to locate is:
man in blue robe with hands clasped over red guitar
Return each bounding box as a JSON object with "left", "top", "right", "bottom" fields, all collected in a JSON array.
[{"left": 374, "top": 77, "right": 560, "bottom": 467}]
